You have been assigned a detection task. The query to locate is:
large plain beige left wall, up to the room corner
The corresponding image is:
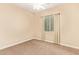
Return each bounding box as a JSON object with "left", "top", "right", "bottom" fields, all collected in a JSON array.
[{"left": 0, "top": 4, "right": 35, "bottom": 49}]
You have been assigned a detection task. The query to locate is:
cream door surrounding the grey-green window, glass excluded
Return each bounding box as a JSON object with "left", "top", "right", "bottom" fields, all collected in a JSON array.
[{"left": 43, "top": 14, "right": 60, "bottom": 44}]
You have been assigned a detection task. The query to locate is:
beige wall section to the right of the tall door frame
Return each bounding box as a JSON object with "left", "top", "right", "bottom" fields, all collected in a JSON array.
[{"left": 61, "top": 4, "right": 79, "bottom": 49}]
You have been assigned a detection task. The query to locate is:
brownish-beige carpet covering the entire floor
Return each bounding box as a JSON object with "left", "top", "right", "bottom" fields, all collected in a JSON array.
[{"left": 0, "top": 39, "right": 79, "bottom": 55}]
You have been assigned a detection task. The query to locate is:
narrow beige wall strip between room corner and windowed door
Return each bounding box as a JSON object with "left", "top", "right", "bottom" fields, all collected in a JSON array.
[{"left": 33, "top": 13, "right": 42, "bottom": 40}]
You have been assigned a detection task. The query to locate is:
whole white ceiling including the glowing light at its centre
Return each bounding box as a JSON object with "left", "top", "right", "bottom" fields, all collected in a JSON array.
[{"left": 16, "top": 3, "right": 60, "bottom": 12}]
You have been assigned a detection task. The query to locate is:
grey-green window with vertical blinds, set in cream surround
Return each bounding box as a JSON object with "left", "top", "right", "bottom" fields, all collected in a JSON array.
[{"left": 44, "top": 15, "right": 54, "bottom": 31}]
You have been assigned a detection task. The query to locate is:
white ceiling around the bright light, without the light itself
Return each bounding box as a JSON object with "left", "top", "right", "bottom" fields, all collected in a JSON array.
[{"left": 16, "top": 3, "right": 60, "bottom": 12}]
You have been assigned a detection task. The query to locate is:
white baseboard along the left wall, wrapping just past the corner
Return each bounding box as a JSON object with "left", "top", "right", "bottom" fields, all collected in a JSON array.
[{"left": 0, "top": 36, "right": 41, "bottom": 50}]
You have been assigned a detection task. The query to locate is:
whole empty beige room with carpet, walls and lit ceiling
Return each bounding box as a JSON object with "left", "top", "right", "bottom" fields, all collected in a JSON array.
[{"left": 0, "top": 3, "right": 79, "bottom": 55}]
